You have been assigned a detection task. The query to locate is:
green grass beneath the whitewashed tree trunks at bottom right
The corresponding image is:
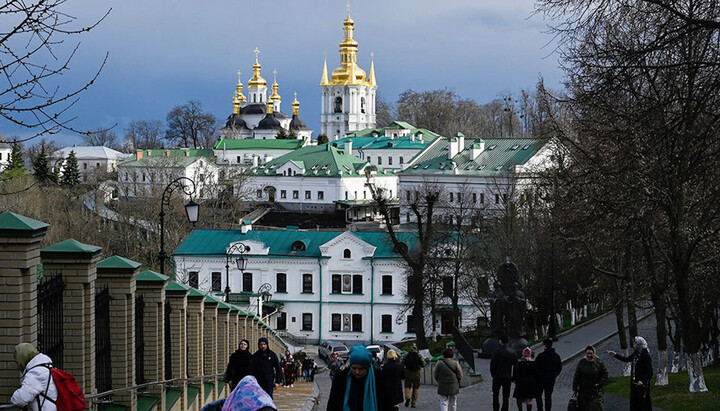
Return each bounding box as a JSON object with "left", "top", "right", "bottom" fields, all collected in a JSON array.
[{"left": 605, "top": 366, "right": 720, "bottom": 411}]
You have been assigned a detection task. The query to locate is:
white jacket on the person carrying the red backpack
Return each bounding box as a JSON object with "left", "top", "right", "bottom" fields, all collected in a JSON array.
[{"left": 10, "top": 354, "right": 57, "bottom": 411}]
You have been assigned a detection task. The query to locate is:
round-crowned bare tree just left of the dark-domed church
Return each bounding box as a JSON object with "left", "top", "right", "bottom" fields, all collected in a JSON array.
[{"left": 165, "top": 100, "right": 218, "bottom": 148}]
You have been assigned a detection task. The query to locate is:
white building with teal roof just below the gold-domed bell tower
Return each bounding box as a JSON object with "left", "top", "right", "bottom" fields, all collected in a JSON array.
[{"left": 333, "top": 121, "right": 440, "bottom": 172}]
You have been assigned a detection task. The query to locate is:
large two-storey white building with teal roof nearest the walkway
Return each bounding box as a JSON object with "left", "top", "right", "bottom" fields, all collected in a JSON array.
[{"left": 171, "top": 226, "right": 477, "bottom": 344}]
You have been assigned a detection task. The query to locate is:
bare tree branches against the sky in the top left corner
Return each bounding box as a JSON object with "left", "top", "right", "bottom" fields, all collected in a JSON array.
[{"left": 0, "top": 0, "right": 110, "bottom": 141}]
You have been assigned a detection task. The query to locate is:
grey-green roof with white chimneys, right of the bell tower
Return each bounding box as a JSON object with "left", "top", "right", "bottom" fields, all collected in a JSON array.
[{"left": 400, "top": 137, "right": 545, "bottom": 177}]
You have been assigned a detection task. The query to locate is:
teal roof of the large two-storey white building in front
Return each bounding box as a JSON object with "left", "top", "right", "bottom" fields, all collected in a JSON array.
[{"left": 173, "top": 230, "right": 417, "bottom": 258}]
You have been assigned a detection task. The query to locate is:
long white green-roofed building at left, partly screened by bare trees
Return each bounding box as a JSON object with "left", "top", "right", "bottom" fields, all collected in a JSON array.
[{"left": 118, "top": 148, "right": 219, "bottom": 199}]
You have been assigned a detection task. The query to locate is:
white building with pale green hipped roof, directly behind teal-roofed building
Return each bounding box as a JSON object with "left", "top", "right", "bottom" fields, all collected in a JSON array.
[{"left": 247, "top": 144, "right": 398, "bottom": 213}]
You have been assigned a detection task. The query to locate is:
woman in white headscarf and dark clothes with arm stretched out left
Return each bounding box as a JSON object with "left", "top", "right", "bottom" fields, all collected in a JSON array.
[{"left": 607, "top": 336, "right": 653, "bottom": 411}]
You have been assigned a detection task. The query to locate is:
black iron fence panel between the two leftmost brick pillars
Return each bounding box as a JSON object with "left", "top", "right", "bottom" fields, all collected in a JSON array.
[{"left": 38, "top": 273, "right": 64, "bottom": 368}]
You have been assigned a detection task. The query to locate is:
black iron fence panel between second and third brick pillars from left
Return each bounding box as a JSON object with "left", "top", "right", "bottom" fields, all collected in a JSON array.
[{"left": 95, "top": 286, "right": 112, "bottom": 392}]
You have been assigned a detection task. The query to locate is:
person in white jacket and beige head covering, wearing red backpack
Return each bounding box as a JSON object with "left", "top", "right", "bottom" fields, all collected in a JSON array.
[{"left": 10, "top": 343, "right": 57, "bottom": 411}]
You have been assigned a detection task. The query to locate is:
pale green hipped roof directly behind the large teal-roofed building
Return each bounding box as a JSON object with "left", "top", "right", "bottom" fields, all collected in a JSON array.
[{"left": 247, "top": 144, "right": 388, "bottom": 178}]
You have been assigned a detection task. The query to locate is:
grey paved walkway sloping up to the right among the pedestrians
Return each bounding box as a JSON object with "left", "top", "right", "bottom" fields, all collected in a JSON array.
[{"left": 296, "top": 313, "right": 662, "bottom": 411}]
